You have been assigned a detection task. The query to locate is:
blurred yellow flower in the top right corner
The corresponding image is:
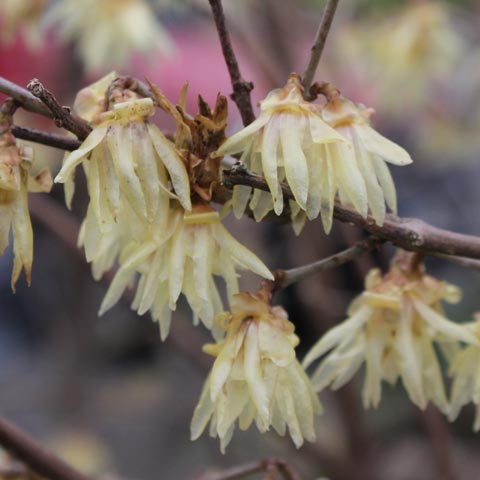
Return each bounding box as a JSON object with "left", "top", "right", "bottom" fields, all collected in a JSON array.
[{"left": 339, "top": 0, "right": 465, "bottom": 113}]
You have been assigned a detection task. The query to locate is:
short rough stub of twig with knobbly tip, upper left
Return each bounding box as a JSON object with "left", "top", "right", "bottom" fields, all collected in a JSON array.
[{"left": 27, "top": 78, "right": 92, "bottom": 140}]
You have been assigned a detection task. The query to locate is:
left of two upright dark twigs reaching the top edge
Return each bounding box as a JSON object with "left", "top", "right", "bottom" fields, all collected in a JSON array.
[{"left": 208, "top": 0, "right": 255, "bottom": 125}]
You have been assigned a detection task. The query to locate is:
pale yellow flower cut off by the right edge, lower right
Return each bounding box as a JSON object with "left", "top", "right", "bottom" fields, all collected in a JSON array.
[{"left": 448, "top": 313, "right": 480, "bottom": 432}]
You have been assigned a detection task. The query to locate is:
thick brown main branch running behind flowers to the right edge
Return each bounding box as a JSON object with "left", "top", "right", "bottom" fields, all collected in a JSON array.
[{"left": 223, "top": 166, "right": 480, "bottom": 259}]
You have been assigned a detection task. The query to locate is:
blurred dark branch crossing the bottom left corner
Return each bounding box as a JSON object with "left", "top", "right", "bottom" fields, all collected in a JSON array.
[{"left": 0, "top": 417, "right": 94, "bottom": 480}]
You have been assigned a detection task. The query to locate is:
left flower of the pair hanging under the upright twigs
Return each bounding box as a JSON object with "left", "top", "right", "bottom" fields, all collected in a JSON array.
[{"left": 216, "top": 74, "right": 348, "bottom": 225}]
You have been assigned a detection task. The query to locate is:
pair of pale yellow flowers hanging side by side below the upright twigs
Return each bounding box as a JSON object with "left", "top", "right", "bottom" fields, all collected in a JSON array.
[{"left": 216, "top": 74, "right": 412, "bottom": 233}]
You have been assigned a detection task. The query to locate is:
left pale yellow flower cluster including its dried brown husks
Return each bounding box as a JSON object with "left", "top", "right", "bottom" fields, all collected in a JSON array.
[{"left": 55, "top": 73, "right": 273, "bottom": 339}]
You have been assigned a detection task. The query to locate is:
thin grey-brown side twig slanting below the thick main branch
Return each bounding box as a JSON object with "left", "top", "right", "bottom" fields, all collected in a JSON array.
[{"left": 275, "top": 237, "right": 383, "bottom": 290}]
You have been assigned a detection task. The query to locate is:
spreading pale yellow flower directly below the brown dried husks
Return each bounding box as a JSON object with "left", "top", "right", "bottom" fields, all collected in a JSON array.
[{"left": 100, "top": 205, "right": 273, "bottom": 339}]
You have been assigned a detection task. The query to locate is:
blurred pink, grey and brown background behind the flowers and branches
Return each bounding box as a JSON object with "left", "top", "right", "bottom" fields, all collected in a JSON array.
[{"left": 0, "top": 0, "right": 480, "bottom": 480}]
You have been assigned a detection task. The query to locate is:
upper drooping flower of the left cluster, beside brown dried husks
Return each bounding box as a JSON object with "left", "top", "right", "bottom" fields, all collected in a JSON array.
[{"left": 55, "top": 73, "right": 191, "bottom": 232}]
